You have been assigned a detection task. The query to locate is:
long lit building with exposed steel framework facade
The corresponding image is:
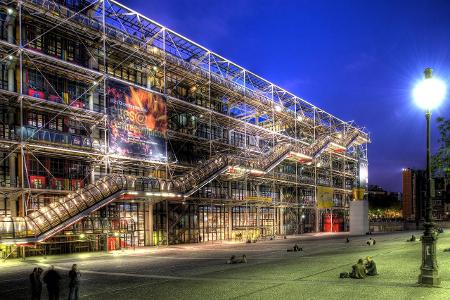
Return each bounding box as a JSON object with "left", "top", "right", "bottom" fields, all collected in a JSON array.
[{"left": 0, "top": 0, "right": 370, "bottom": 255}]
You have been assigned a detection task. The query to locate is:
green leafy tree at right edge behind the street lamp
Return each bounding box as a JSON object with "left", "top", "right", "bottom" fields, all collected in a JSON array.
[{"left": 431, "top": 117, "right": 450, "bottom": 177}]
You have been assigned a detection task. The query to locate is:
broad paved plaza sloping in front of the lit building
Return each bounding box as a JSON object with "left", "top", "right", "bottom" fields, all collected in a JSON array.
[{"left": 0, "top": 232, "right": 450, "bottom": 300}]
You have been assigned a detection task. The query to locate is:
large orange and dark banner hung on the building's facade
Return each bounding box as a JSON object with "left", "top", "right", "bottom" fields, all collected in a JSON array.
[{"left": 107, "top": 80, "right": 167, "bottom": 161}]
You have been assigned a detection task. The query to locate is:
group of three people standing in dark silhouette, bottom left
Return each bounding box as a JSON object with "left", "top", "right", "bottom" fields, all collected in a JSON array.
[{"left": 30, "top": 264, "right": 81, "bottom": 300}]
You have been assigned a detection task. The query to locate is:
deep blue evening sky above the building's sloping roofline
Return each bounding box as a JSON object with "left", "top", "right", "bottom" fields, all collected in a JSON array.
[{"left": 122, "top": 0, "right": 450, "bottom": 191}]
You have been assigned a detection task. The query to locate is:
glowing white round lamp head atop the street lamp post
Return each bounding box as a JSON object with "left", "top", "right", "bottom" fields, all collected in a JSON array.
[{"left": 413, "top": 68, "right": 447, "bottom": 110}]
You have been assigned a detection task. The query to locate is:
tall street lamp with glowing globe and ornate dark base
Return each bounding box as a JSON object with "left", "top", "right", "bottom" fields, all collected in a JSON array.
[{"left": 413, "top": 68, "right": 446, "bottom": 286}]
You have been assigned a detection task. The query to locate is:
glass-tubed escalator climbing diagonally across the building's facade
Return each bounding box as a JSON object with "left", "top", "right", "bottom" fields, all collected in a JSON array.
[{"left": 0, "top": 138, "right": 348, "bottom": 244}]
